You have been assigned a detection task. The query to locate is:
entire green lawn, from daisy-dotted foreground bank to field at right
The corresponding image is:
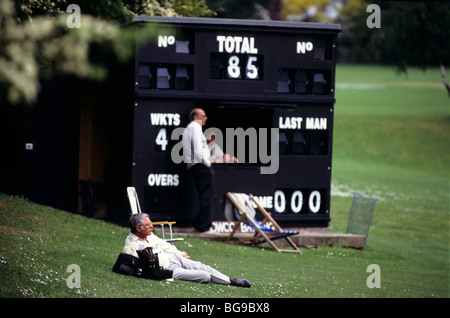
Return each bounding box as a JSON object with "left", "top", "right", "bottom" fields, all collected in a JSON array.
[{"left": 0, "top": 66, "right": 450, "bottom": 298}]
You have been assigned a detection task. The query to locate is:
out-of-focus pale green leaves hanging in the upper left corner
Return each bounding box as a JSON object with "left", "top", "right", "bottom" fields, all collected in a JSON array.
[{"left": 0, "top": 0, "right": 130, "bottom": 104}]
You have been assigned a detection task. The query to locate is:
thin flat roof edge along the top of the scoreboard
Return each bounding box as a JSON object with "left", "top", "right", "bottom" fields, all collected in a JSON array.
[{"left": 131, "top": 15, "right": 342, "bottom": 32}]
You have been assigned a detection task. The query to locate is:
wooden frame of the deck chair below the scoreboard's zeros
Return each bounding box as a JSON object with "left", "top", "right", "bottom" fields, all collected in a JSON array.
[{"left": 225, "top": 192, "right": 302, "bottom": 254}]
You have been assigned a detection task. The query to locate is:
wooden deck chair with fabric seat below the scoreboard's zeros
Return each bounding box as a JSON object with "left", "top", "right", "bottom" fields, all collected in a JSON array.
[{"left": 225, "top": 192, "right": 302, "bottom": 254}]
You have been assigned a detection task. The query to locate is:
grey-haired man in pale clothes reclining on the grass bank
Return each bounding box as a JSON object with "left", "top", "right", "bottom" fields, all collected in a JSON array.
[{"left": 122, "top": 213, "right": 251, "bottom": 287}]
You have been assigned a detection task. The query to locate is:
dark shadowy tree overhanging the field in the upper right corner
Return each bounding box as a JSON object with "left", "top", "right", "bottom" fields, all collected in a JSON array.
[{"left": 337, "top": 0, "right": 450, "bottom": 95}]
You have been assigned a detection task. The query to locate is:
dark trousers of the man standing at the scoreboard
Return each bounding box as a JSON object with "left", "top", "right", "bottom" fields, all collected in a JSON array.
[{"left": 189, "top": 163, "right": 216, "bottom": 232}]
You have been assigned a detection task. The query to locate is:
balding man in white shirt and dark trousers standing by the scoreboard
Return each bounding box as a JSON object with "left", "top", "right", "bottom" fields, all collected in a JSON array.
[{"left": 183, "top": 108, "right": 216, "bottom": 232}]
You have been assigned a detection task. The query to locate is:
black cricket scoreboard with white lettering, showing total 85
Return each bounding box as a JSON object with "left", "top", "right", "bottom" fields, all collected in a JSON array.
[{"left": 131, "top": 16, "right": 340, "bottom": 227}]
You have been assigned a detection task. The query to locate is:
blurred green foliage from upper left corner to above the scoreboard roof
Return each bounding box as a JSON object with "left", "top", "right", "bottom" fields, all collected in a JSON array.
[{"left": 0, "top": 0, "right": 214, "bottom": 104}]
